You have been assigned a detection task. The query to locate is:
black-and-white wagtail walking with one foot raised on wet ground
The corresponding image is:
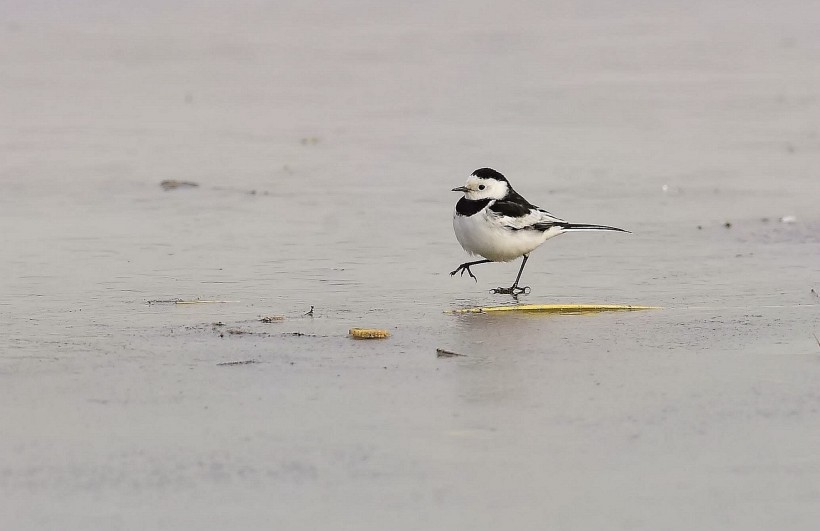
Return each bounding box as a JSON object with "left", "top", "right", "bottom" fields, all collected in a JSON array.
[{"left": 450, "top": 168, "right": 629, "bottom": 295}]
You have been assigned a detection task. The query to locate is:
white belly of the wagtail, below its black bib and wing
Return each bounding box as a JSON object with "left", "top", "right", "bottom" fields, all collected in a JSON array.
[{"left": 453, "top": 210, "right": 563, "bottom": 262}]
